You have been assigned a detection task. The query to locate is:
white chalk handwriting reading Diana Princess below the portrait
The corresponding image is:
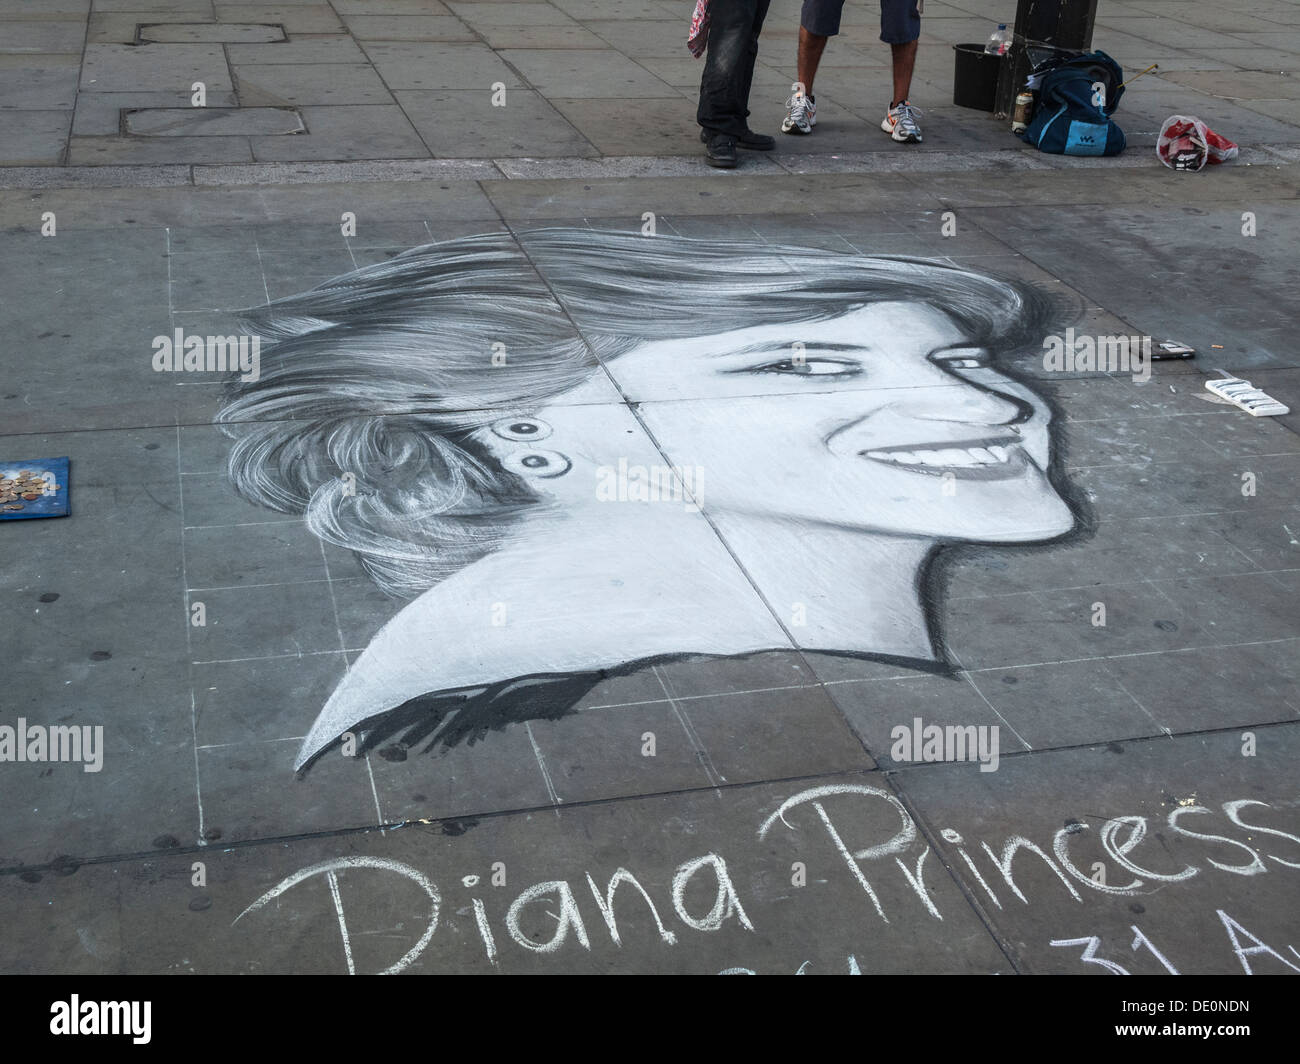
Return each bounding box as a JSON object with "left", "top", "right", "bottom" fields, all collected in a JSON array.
[{"left": 234, "top": 783, "right": 1300, "bottom": 974}]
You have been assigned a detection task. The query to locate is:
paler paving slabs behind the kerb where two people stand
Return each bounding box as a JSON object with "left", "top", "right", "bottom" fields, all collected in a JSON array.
[{"left": 0, "top": 0, "right": 1300, "bottom": 173}]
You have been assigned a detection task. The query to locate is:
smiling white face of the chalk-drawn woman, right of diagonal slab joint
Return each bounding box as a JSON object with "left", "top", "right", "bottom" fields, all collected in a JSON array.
[{"left": 522, "top": 302, "right": 1073, "bottom": 542}]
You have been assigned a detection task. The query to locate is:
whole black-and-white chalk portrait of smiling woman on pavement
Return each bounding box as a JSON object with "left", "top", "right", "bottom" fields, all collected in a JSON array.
[{"left": 220, "top": 229, "right": 1079, "bottom": 769}]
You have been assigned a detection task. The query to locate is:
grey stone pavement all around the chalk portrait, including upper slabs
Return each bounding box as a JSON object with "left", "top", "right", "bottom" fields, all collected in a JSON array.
[{"left": 0, "top": 0, "right": 1300, "bottom": 974}]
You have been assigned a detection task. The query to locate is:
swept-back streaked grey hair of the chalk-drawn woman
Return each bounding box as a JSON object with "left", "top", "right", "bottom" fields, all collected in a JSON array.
[{"left": 218, "top": 229, "right": 1062, "bottom": 597}]
